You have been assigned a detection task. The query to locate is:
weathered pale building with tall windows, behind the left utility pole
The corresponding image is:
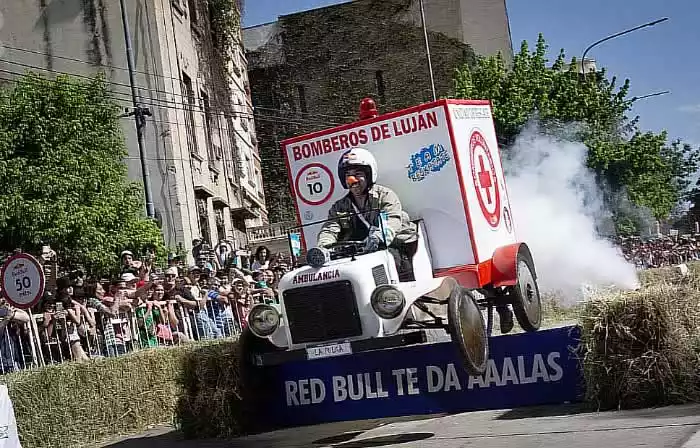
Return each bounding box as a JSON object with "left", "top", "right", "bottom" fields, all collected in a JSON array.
[{"left": 0, "top": 0, "right": 267, "bottom": 262}]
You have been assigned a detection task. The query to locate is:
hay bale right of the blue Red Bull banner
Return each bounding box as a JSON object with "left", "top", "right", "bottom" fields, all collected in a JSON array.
[{"left": 581, "top": 282, "right": 700, "bottom": 409}]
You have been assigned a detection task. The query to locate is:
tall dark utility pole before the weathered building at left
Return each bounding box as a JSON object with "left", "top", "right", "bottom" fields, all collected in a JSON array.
[{"left": 119, "top": 0, "right": 155, "bottom": 218}]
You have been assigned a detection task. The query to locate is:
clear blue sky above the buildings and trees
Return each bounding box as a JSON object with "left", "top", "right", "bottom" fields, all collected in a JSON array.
[{"left": 243, "top": 0, "right": 700, "bottom": 145}]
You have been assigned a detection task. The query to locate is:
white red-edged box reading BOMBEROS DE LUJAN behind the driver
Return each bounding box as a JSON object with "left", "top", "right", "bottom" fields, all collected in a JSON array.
[{"left": 282, "top": 100, "right": 517, "bottom": 271}]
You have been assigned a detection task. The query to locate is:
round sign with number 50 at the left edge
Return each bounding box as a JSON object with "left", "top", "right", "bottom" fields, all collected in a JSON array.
[{"left": 0, "top": 254, "right": 45, "bottom": 309}]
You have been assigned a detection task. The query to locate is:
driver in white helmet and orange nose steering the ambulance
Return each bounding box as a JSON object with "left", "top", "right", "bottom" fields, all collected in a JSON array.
[{"left": 317, "top": 148, "right": 418, "bottom": 282}]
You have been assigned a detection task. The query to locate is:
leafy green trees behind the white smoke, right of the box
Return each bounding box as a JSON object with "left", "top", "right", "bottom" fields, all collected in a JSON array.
[{"left": 455, "top": 35, "right": 700, "bottom": 224}]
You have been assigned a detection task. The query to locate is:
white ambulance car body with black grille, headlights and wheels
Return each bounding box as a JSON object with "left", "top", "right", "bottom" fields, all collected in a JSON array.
[{"left": 241, "top": 212, "right": 542, "bottom": 375}]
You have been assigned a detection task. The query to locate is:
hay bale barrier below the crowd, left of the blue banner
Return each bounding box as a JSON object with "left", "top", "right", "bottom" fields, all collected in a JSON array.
[{"left": 3, "top": 341, "right": 235, "bottom": 448}]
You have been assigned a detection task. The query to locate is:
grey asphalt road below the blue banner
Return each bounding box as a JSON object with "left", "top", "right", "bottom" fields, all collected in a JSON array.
[{"left": 101, "top": 405, "right": 700, "bottom": 448}]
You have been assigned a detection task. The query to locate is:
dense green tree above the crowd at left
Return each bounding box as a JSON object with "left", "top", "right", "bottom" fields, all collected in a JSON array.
[{"left": 0, "top": 73, "right": 165, "bottom": 274}]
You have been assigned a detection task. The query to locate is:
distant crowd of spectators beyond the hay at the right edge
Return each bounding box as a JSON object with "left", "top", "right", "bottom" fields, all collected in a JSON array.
[{"left": 618, "top": 234, "right": 700, "bottom": 269}]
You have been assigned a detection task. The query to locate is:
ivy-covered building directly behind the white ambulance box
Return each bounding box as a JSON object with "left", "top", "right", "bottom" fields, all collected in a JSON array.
[{"left": 243, "top": 0, "right": 512, "bottom": 223}]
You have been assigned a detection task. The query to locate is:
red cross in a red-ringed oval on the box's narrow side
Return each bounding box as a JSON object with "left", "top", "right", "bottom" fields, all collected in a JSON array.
[{"left": 469, "top": 130, "right": 501, "bottom": 229}]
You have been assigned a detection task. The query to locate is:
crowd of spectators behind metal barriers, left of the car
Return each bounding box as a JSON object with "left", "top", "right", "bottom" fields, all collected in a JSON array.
[{"left": 0, "top": 240, "right": 291, "bottom": 373}]
